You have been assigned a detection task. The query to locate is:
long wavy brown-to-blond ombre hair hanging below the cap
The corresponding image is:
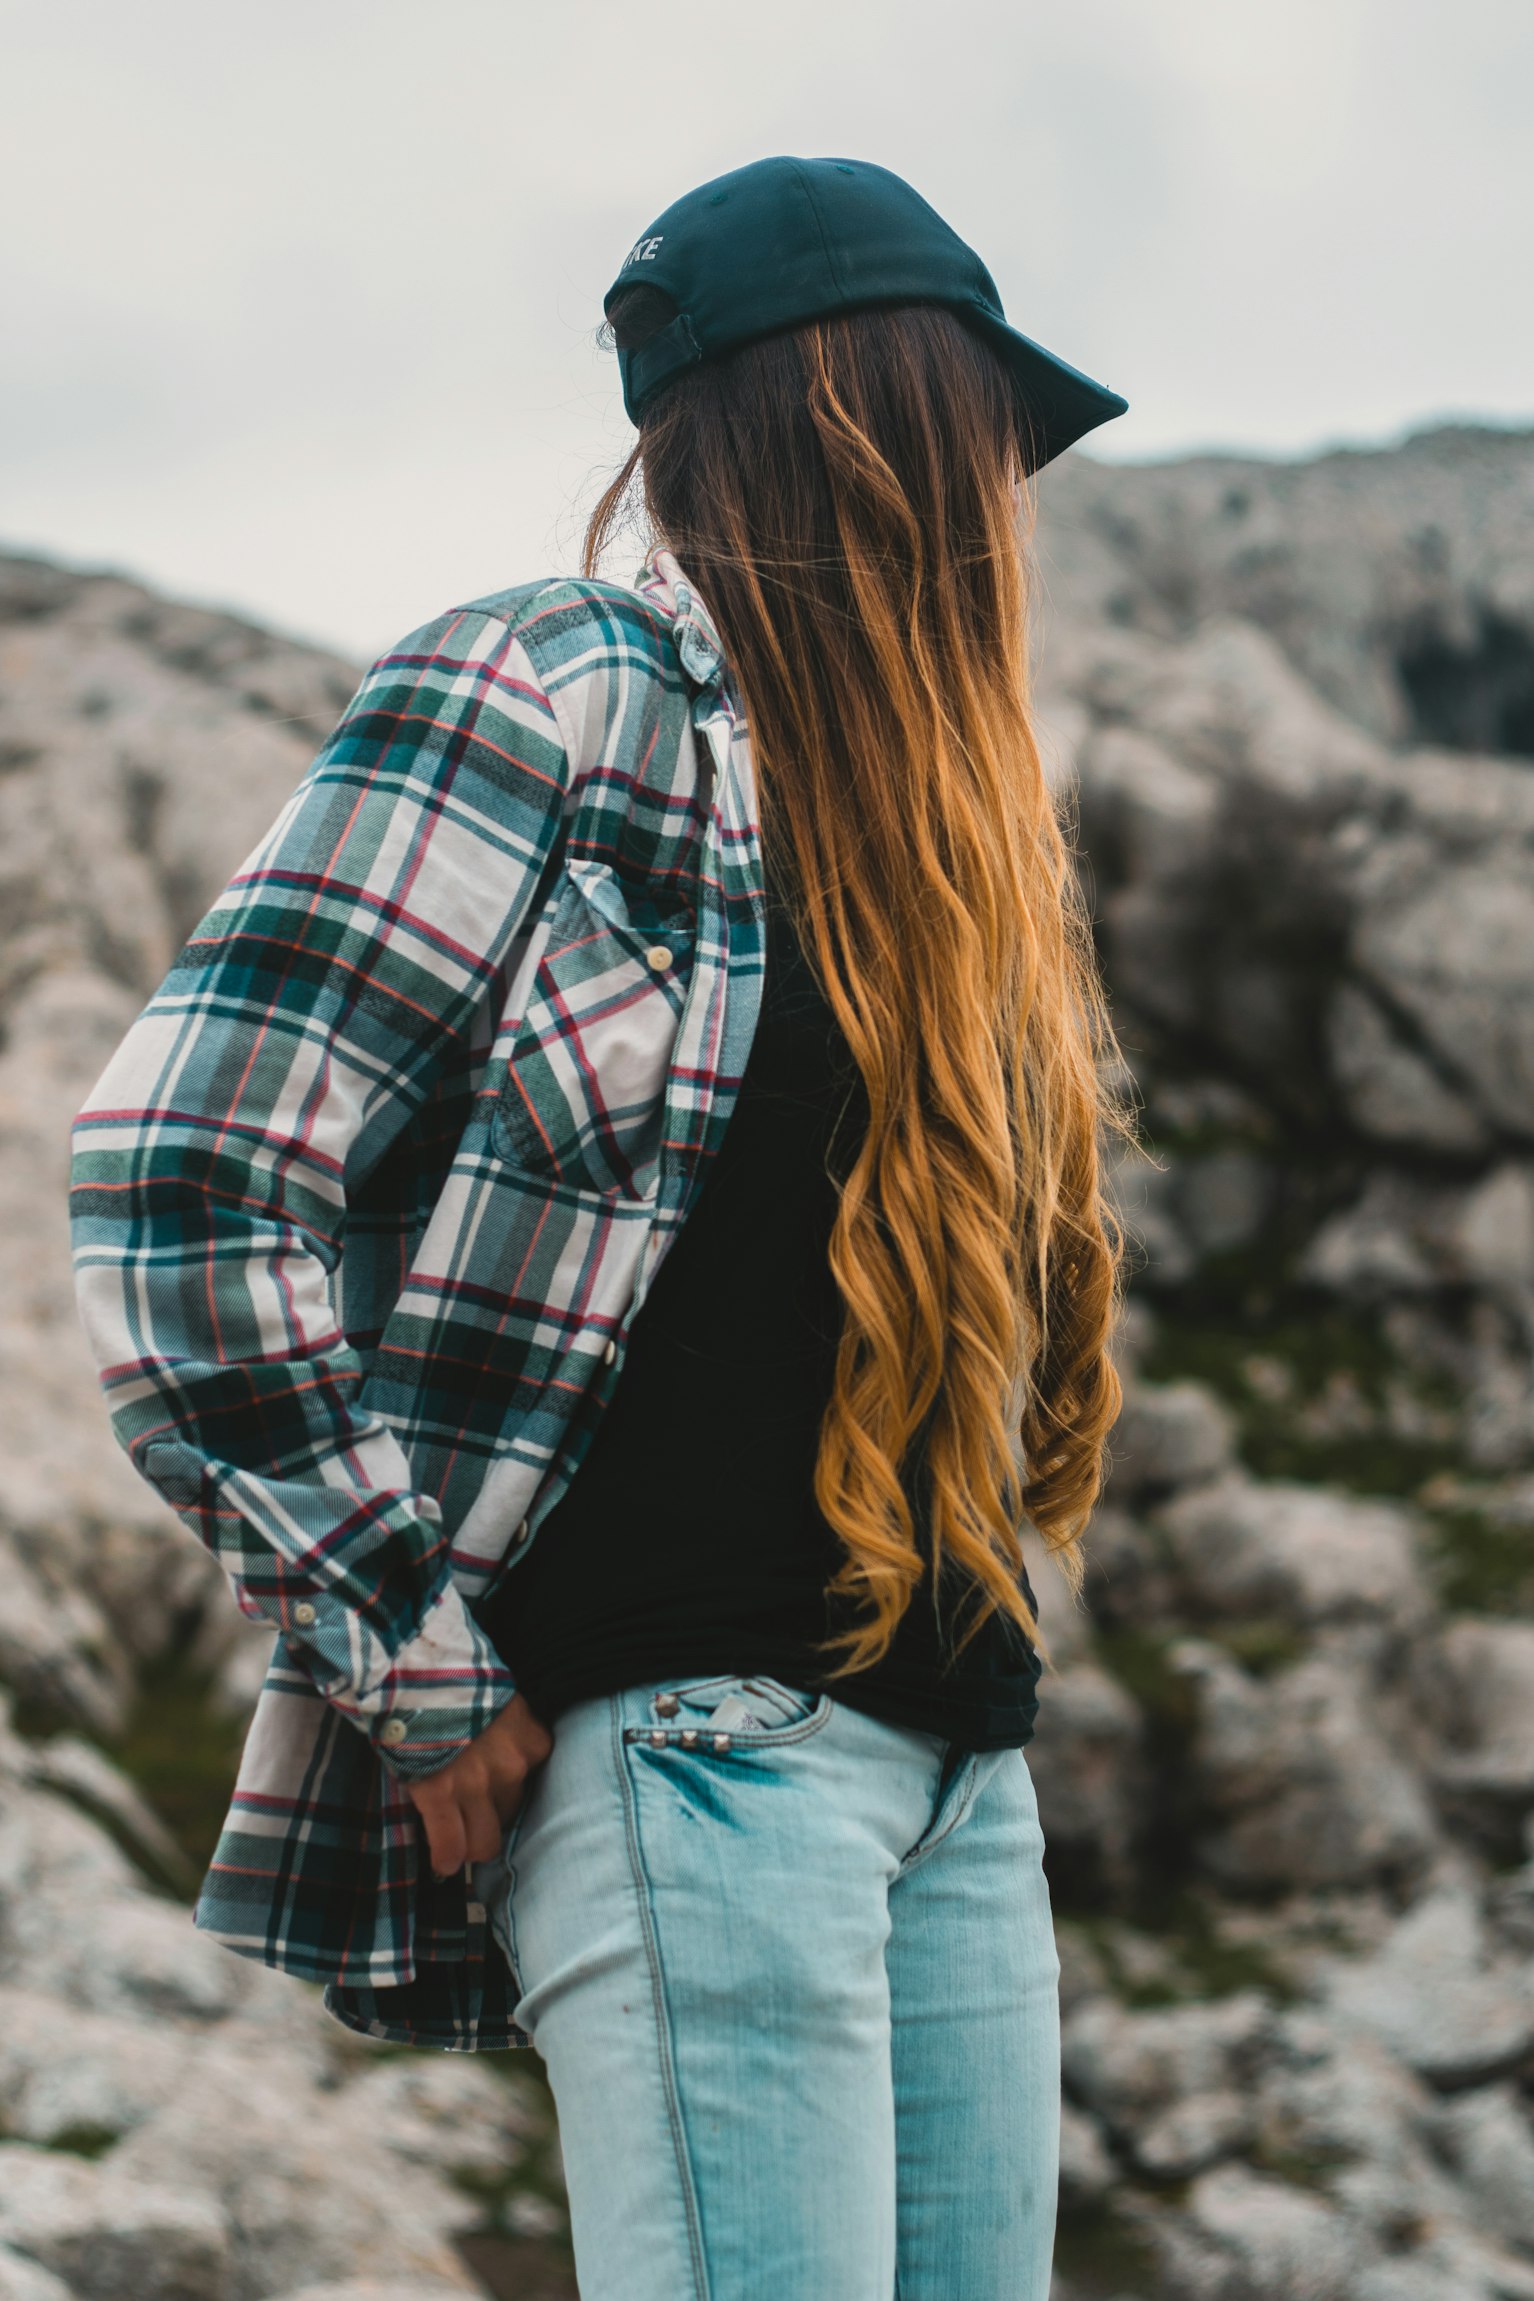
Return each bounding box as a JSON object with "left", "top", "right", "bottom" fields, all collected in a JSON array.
[{"left": 584, "top": 288, "right": 1120, "bottom": 1675}]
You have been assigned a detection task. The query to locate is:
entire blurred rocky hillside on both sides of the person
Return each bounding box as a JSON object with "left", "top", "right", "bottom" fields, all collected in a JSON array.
[{"left": 0, "top": 430, "right": 1534, "bottom": 2301}]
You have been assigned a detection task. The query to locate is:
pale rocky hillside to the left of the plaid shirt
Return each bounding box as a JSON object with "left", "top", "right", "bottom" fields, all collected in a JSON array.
[{"left": 0, "top": 559, "right": 573, "bottom": 2301}]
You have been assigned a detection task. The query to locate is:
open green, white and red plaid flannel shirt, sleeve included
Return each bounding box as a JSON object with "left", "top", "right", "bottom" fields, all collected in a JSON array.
[{"left": 71, "top": 552, "right": 764, "bottom": 2050}]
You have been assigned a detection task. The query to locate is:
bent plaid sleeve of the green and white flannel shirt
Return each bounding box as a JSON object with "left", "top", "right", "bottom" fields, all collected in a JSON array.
[{"left": 71, "top": 610, "right": 568, "bottom": 1776}]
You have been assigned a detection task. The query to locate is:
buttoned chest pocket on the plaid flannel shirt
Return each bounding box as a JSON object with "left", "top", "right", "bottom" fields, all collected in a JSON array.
[{"left": 492, "top": 863, "right": 695, "bottom": 1199}]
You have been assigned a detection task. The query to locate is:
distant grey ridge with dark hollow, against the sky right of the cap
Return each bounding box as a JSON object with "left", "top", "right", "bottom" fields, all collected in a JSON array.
[{"left": 1042, "top": 423, "right": 1534, "bottom": 764}]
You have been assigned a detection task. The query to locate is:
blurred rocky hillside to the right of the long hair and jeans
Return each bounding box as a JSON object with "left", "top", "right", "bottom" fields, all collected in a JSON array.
[{"left": 1035, "top": 430, "right": 1534, "bottom": 2301}]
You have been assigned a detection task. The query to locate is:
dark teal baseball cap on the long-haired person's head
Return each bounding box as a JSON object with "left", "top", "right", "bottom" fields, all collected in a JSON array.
[{"left": 603, "top": 156, "right": 1129, "bottom": 472}]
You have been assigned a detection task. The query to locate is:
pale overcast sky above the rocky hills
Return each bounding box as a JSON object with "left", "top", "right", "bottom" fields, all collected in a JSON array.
[{"left": 0, "top": 0, "right": 1534, "bottom": 653}]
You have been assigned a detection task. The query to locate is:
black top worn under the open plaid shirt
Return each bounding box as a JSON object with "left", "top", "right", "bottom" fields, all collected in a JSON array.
[{"left": 481, "top": 860, "right": 1040, "bottom": 1749}]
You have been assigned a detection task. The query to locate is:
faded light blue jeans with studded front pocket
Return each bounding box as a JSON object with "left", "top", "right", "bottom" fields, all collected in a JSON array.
[{"left": 481, "top": 1677, "right": 1060, "bottom": 2301}]
